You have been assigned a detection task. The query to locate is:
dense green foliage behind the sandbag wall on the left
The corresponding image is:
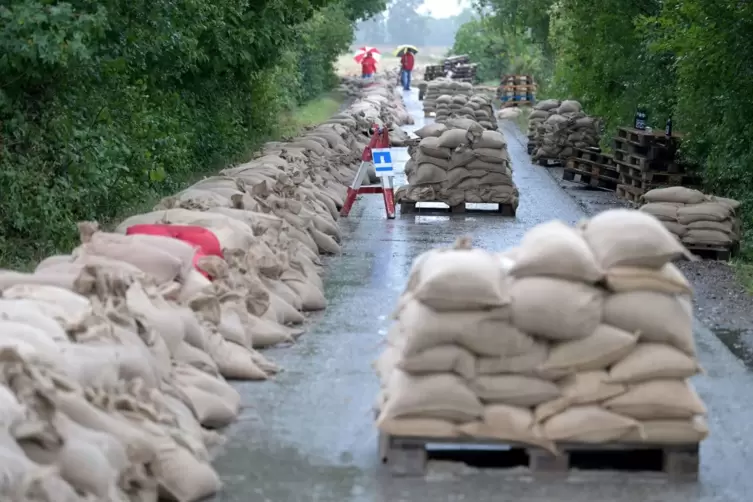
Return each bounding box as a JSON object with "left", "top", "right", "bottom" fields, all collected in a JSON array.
[{"left": 0, "top": 0, "right": 378, "bottom": 265}]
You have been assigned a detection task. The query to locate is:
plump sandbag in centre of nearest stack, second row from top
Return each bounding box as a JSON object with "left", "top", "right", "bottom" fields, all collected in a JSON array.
[{"left": 510, "top": 277, "right": 604, "bottom": 341}]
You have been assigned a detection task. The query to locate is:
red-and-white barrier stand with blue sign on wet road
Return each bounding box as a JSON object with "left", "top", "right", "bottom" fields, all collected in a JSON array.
[{"left": 340, "top": 125, "right": 395, "bottom": 220}]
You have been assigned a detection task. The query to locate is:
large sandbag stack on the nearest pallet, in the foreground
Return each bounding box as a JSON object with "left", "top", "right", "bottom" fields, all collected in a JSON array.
[{"left": 375, "top": 209, "right": 708, "bottom": 452}]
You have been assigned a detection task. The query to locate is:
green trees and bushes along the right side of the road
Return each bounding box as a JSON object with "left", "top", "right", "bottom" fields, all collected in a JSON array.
[{"left": 455, "top": 0, "right": 753, "bottom": 285}]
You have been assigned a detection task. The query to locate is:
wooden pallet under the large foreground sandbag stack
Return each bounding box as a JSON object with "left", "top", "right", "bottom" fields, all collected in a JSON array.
[{"left": 379, "top": 433, "right": 699, "bottom": 481}]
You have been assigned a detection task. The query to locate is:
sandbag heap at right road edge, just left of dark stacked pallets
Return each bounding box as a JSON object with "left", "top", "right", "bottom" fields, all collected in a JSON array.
[{"left": 533, "top": 101, "right": 601, "bottom": 159}]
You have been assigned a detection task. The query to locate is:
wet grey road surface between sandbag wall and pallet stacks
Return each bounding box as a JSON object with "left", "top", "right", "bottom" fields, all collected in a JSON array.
[{"left": 209, "top": 90, "right": 753, "bottom": 502}]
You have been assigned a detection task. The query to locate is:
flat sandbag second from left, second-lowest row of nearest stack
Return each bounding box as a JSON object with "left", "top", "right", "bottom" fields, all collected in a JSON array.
[{"left": 470, "top": 375, "right": 560, "bottom": 408}]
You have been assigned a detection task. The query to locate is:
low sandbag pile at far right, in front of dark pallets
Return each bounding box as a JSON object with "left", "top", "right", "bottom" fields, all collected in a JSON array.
[{"left": 640, "top": 187, "right": 740, "bottom": 249}]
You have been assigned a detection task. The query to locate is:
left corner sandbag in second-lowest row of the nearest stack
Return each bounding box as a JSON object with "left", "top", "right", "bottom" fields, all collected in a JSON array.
[{"left": 380, "top": 369, "right": 484, "bottom": 423}]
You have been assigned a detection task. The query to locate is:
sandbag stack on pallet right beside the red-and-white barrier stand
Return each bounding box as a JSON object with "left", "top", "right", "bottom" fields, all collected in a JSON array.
[{"left": 395, "top": 118, "right": 519, "bottom": 208}]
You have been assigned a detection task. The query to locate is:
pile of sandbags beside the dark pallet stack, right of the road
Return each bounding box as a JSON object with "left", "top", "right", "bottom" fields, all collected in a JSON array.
[{"left": 528, "top": 99, "right": 601, "bottom": 160}]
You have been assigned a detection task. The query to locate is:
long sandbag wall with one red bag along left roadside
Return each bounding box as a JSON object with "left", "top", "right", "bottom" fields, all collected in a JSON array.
[{"left": 0, "top": 75, "right": 412, "bottom": 502}]
